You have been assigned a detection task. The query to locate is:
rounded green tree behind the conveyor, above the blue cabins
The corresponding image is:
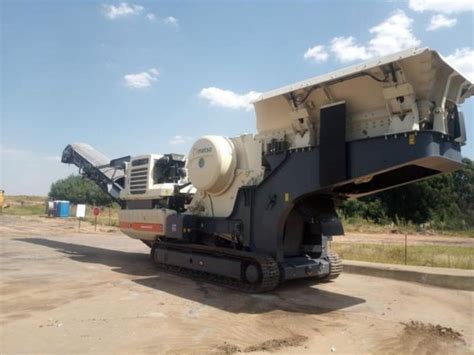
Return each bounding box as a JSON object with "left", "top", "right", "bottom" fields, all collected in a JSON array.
[{"left": 48, "top": 175, "right": 113, "bottom": 206}]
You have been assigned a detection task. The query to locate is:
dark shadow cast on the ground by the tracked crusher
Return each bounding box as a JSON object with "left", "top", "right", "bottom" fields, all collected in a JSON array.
[{"left": 15, "top": 238, "right": 365, "bottom": 314}]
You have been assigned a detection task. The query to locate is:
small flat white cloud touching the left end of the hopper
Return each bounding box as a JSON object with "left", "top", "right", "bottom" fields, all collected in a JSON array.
[{"left": 199, "top": 87, "right": 261, "bottom": 111}]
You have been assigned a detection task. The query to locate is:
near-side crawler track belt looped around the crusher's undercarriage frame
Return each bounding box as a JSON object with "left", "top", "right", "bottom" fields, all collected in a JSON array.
[{"left": 151, "top": 242, "right": 280, "bottom": 293}]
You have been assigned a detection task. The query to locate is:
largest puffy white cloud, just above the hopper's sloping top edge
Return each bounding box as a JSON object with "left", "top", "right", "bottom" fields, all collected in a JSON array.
[{"left": 320, "top": 10, "right": 420, "bottom": 62}]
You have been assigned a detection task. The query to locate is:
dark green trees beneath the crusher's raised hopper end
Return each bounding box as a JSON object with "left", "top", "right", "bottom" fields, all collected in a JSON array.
[{"left": 340, "top": 159, "right": 474, "bottom": 229}]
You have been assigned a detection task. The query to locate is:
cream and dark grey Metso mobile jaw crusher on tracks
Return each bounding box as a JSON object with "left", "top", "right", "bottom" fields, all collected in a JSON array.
[{"left": 62, "top": 49, "right": 474, "bottom": 292}]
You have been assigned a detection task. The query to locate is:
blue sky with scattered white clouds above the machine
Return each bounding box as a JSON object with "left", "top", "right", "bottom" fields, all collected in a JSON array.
[{"left": 0, "top": 0, "right": 474, "bottom": 195}]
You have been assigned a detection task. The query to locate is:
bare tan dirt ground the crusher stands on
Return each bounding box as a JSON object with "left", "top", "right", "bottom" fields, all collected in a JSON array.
[{"left": 0, "top": 215, "right": 474, "bottom": 354}]
